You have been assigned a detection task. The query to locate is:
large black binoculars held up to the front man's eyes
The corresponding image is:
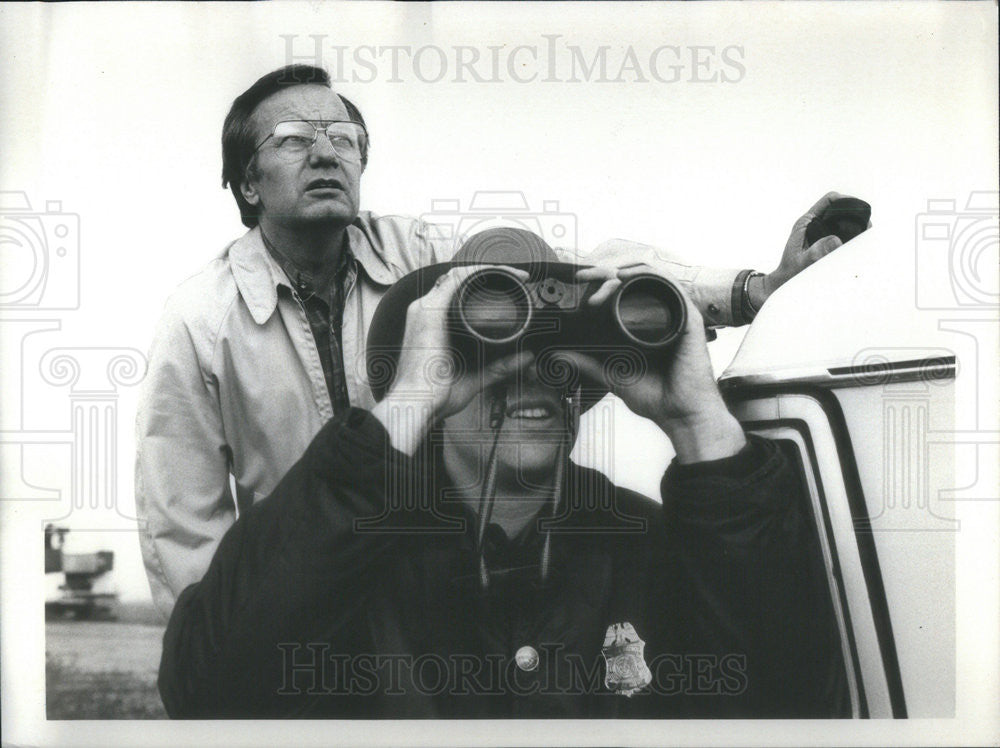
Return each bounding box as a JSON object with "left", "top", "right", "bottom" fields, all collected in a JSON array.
[{"left": 449, "top": 267, "right": 687, "bottom": 355}]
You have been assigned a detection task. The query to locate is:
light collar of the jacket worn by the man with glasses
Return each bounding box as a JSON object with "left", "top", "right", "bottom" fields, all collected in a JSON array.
[{"left": 228, "top": 222, "right": 396, "bottom": 325}]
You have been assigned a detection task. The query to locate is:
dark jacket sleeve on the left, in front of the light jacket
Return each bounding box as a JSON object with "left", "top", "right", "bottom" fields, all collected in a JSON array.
[{"left": 159, "top": 408, "right": 412, "bottom": 717}]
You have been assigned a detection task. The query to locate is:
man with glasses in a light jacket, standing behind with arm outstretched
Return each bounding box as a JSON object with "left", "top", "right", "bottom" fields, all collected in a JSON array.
[{"left": 136, "top": 65, "right": 852, "bottom": 614}]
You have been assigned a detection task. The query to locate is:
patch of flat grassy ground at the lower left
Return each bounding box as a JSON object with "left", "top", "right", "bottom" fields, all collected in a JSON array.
[{"left": 45, "top": 621, "right": 167, "bottom": 719}]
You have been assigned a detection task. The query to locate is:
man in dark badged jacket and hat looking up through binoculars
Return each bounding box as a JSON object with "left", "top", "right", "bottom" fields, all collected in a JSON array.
[{"left": 160, "top": 229, "right": 845, "bottom": 718}]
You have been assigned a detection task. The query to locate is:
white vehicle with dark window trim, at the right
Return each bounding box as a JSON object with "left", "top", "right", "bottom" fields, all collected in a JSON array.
[{"left": 719, "top": 223, "right": 984, "bottom": 718}]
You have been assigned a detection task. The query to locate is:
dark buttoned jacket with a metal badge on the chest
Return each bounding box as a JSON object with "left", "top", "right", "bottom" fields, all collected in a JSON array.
[{"left": 159, "top": 409, "right": 846, "bottom": 718}]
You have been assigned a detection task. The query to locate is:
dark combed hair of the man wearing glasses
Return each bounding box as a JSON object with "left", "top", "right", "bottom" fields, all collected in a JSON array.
[{"left": 222, "top": 65, "right": 368, "bottom": 228}]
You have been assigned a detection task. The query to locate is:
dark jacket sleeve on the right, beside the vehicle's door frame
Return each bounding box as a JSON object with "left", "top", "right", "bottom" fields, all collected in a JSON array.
[{"left": 661, "top": 436, "right": 846, "bottom": 718}]
